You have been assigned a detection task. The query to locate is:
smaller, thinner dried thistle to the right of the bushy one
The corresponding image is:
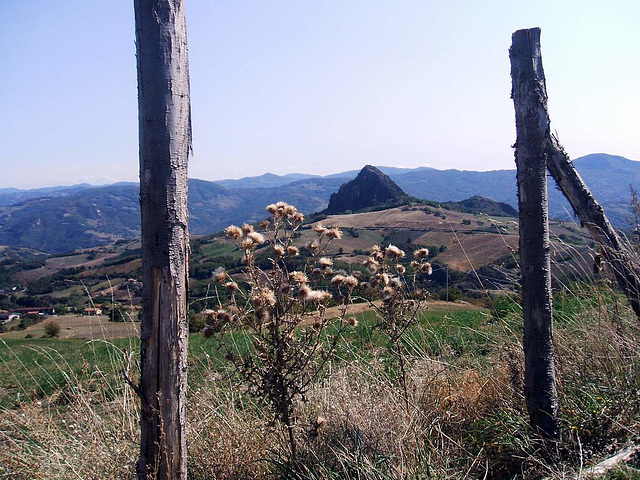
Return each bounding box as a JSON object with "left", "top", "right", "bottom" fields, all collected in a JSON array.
[{"left": 365, "top": 244, "right": 433, "bottom": 412}]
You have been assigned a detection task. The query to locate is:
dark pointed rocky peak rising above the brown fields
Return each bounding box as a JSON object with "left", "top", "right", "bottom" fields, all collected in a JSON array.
[{"left": 324, "top": 165, "right": 407, "bottom": 214}]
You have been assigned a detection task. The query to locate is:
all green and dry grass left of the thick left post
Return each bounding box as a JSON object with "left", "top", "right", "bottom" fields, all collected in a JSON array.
[{"left": 0, "top": 341, "right": 137, "bottom": 479}]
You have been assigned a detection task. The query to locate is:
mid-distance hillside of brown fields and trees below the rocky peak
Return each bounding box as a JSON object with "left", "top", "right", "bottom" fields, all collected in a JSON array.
[{"left": 0, "top": 204, "right": 592, "bottom": 318}]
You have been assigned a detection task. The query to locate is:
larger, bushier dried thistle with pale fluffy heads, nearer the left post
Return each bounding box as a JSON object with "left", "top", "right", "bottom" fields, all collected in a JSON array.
[{"left": 203, "top": 202, "right": 359, "bottom": 464}]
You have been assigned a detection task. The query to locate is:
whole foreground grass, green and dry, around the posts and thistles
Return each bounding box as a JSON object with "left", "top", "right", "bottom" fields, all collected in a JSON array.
[{"left": 0, "top": 288, "right": 640, "bottom": 480}]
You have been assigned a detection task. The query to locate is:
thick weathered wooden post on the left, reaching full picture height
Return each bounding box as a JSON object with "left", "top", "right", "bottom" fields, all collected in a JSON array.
[{"left": 134, "top": 0, "right": 191, "bottom": 480}]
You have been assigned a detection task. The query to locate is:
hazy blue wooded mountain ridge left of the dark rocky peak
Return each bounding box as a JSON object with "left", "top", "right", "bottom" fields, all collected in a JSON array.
[{"left": 0, "top": 178, "right": 341, "bottom": 253}]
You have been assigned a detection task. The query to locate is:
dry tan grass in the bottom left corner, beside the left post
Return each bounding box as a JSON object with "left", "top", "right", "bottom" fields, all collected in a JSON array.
[{"left": 0, "top": 399, "right": 137, "bottom": 479}]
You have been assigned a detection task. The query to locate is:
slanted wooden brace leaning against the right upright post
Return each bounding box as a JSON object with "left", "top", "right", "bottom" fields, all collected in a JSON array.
[{"left": 547, "top": 135, "right": 640, "bottom": 318}]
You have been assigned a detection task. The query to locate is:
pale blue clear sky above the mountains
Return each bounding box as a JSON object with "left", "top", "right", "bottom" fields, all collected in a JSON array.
[{"left": 0, "top": 0, "right": 640, "bottom": 188}]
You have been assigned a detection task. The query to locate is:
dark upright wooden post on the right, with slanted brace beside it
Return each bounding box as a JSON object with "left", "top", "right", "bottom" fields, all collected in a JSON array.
[{"left": 509, "top": 28, "right": 560, "bottom": 440}]
